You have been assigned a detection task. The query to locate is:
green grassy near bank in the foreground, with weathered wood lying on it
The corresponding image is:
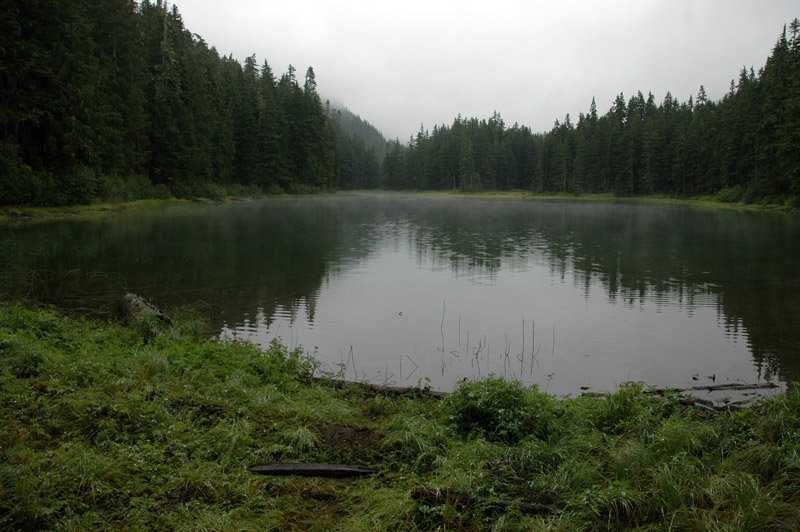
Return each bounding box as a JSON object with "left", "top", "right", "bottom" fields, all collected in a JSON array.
[{"left": 0, "top": 304, "right": 800, "bottom": 531}]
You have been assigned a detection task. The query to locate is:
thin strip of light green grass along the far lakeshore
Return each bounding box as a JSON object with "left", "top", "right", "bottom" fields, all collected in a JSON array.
[{"left": 0, "top": 190, "right": 800, "bottom": 222}]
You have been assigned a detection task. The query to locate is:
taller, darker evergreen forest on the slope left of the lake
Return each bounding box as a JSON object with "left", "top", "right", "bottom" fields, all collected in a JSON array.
[{"left": 0, "top": 0, "right": 379, "bottom": 205}]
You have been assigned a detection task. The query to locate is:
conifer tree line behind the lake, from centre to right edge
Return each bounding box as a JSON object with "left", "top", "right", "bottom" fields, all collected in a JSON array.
[{"left": 382, "top": 19, "right": 800, "bottom": 201}]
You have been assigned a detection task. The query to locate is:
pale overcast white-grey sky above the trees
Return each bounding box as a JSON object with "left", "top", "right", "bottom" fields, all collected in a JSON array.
[{"left": 170, "top": 0, "right": 800, "bottom": 141}]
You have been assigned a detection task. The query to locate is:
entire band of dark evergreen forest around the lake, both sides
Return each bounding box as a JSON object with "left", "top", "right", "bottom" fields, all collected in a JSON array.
[{"left": 0, "top": 0, "right": 800, "bottom": 205}]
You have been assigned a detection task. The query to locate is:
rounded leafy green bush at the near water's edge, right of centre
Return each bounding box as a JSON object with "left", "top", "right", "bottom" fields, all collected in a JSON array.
[{"left": 443, "top": 376, "right": 558, "bottom": 442}]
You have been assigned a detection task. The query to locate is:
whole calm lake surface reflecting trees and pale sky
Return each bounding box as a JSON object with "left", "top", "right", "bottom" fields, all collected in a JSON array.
[{"left": 0, "top": 194, "right": 800, "bottom": 395}]
